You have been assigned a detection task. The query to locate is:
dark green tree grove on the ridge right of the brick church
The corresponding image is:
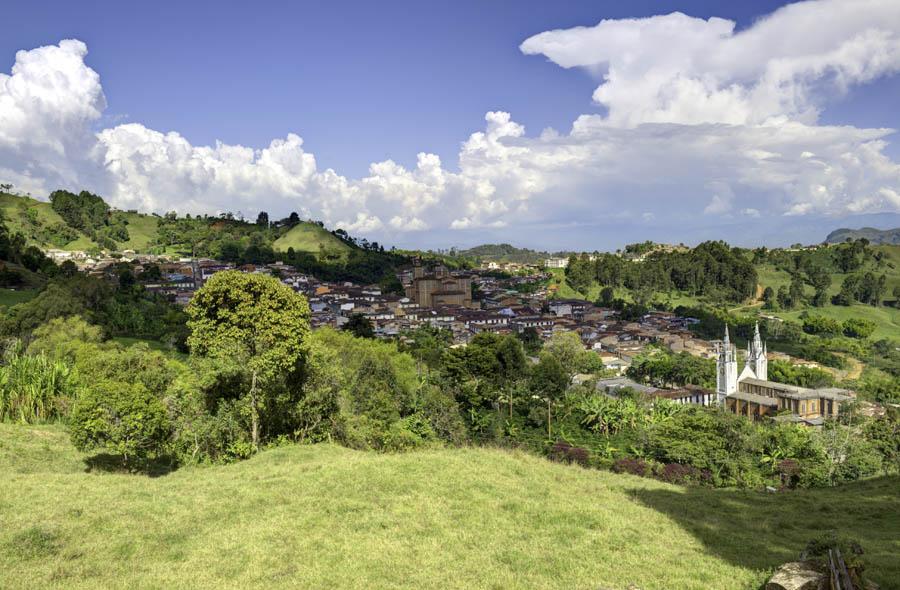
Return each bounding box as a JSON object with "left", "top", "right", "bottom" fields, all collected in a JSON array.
[{"left": 566, "top": 242, "right": 757, "bottom": 301}]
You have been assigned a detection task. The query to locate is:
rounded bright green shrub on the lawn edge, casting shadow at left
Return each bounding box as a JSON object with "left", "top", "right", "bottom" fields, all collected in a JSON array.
[{"left": 70, "top": 381, "right": 171, "bottom": 465}]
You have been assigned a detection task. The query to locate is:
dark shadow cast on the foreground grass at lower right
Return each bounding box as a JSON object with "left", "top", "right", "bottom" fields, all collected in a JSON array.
[{"left": 629, "top": 476, "right": 900, "bottom": 590}]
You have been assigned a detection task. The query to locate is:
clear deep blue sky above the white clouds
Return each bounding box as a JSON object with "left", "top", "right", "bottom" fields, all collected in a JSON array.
[{"left": 0, "top": 0, "right": 804, "bottom": 177}]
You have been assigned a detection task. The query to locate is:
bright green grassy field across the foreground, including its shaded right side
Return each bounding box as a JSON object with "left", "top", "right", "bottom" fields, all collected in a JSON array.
[{"left": 0, "top": 424, "right": 900, "bottom": 590}]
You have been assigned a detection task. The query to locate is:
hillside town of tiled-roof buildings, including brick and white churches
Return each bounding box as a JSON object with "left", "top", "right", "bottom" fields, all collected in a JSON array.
[{"left": 40, "top": 243, "right": 878, "bottom": 426}]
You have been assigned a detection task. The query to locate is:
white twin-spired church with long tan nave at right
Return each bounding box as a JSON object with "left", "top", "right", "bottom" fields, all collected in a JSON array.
[{"left": 715, "top": 323, "right": 853, "bottom": 426}]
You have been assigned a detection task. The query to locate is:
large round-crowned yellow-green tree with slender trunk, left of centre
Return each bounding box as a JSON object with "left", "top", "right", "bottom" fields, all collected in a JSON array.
[{"left": 187, "top": 271, "right": 309, "bottom": 448}]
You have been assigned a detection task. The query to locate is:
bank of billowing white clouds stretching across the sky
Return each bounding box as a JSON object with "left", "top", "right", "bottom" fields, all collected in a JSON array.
[{"left": 0, "top": 0, "right": 900, "bottom": 249}]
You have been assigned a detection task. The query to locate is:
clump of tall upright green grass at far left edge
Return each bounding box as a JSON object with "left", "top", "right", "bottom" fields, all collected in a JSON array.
[{"left": 0, "top": 341, "right": 76, "bottom": 423}]
